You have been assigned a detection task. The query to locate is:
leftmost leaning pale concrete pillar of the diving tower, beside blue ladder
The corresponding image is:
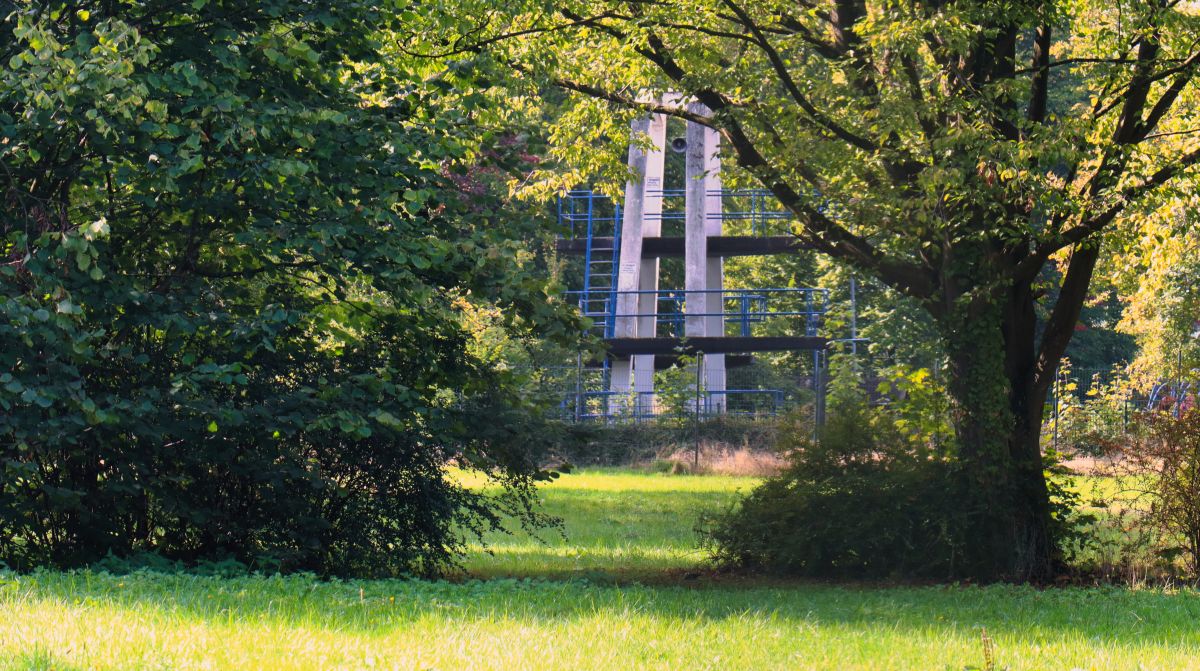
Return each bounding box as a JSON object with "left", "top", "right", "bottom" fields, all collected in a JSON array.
[{"left": 608, "top": 115, "right": 650, "bottom": 414}]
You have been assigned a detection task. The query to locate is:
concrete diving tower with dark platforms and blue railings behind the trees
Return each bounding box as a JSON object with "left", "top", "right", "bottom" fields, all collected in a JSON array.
[{"left": 558, "top": 96, "right": 827, "bottom": 415}]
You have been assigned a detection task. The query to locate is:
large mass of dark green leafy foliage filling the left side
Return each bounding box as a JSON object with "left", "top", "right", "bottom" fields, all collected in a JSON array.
[{"left": 0, "top": 1, "right": 564, "bottom": 574}]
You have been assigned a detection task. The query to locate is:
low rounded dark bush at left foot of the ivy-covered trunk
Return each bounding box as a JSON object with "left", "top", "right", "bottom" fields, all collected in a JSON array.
[{"left": 704, "top": 408, "right": 962, "bottom": 577}]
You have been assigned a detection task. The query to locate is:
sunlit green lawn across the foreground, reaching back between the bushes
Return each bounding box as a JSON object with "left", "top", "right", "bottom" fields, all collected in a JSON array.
[{"left": 7, "top": 472, "right": 1200, "bottom": 671}]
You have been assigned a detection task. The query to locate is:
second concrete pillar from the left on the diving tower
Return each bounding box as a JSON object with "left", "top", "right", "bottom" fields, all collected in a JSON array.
[{"left": 634, "top": 108, "right": 667, "bottom": 414}]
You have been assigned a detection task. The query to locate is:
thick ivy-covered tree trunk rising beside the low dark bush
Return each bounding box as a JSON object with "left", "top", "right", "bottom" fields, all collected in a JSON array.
[{"left": 942, "top": 286, "right": 1057, "bottom": 582}]
